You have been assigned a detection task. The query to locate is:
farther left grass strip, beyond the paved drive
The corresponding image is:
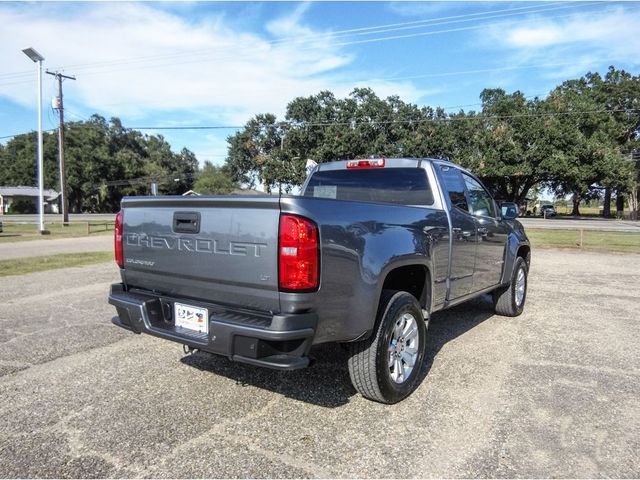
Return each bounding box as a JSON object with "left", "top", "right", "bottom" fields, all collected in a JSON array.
[{"left": 0, "top": 220, "right": 113, "bottom": 242}]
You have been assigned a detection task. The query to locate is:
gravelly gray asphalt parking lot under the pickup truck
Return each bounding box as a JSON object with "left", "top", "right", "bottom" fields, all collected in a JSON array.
[{"left": 0, "top": 250, "right": 640, "bottom": 478}]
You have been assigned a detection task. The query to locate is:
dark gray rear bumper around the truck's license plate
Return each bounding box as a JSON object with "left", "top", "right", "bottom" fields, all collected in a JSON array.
[{"left": 109, "top": 283, "right": 318, "bottom": 370}]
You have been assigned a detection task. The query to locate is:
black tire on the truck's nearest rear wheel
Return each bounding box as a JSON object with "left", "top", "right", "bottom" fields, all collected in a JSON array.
[{"left": 348, "top": 290, "right": 427, "bottom": 404}]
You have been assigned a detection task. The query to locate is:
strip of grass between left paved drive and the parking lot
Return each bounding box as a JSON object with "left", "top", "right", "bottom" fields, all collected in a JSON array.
[{"left": 0, "top": 252, "right": 113, "bottom": 277}]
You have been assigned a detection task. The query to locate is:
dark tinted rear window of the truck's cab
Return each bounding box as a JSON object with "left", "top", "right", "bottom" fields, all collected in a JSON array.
[{"left": 304, "top": 168, "right": 433, "bottom": 205}]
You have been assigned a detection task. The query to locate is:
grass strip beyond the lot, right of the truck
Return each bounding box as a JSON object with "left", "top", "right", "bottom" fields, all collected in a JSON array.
[{"left": 526, "top": 228, "right": 640, "bottom": 253}]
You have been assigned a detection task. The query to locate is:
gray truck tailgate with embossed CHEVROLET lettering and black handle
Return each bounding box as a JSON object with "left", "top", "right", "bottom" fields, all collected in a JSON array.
[{"left": 122, "top": 196, "right": 280, "bottom": 312}]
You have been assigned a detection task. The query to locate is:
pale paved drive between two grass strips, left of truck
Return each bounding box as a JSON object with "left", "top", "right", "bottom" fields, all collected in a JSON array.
[{"left": 0, "top": 235, "right": 113, "bottom": 260}]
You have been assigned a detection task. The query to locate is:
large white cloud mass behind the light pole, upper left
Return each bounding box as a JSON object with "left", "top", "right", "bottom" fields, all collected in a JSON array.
[{"left": 0, "top": 3, "right": 422, "bottom": 124}]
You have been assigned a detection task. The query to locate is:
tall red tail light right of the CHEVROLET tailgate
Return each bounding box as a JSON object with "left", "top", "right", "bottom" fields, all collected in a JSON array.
[{"left": 278, "top": 214, "right": 320, "bottom": 292}]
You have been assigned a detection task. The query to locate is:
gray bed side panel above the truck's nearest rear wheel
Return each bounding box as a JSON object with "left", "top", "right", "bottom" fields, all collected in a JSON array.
[{"left": 280, "top": 197, "right": 448, "bottom": 343}]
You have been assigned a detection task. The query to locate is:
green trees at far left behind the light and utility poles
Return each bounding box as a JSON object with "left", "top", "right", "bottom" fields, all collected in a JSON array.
[{"left": 0, "top": 115, "right": 198, "bottom": 212}]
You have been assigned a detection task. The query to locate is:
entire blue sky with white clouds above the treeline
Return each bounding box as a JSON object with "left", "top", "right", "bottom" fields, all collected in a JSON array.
[{"left": 0, "top": 2, "right": 640, "bottom": 163}]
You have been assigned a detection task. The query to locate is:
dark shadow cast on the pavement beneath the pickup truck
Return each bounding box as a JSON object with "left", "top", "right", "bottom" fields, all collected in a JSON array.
[{"left": 181, "top": 296, "right": 494, "bottom": 408}]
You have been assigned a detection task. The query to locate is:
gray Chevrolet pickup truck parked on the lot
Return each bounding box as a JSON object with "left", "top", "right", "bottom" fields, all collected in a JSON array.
[{"left": 109, "top": 158, "right": 531, "bottom": 403}]
